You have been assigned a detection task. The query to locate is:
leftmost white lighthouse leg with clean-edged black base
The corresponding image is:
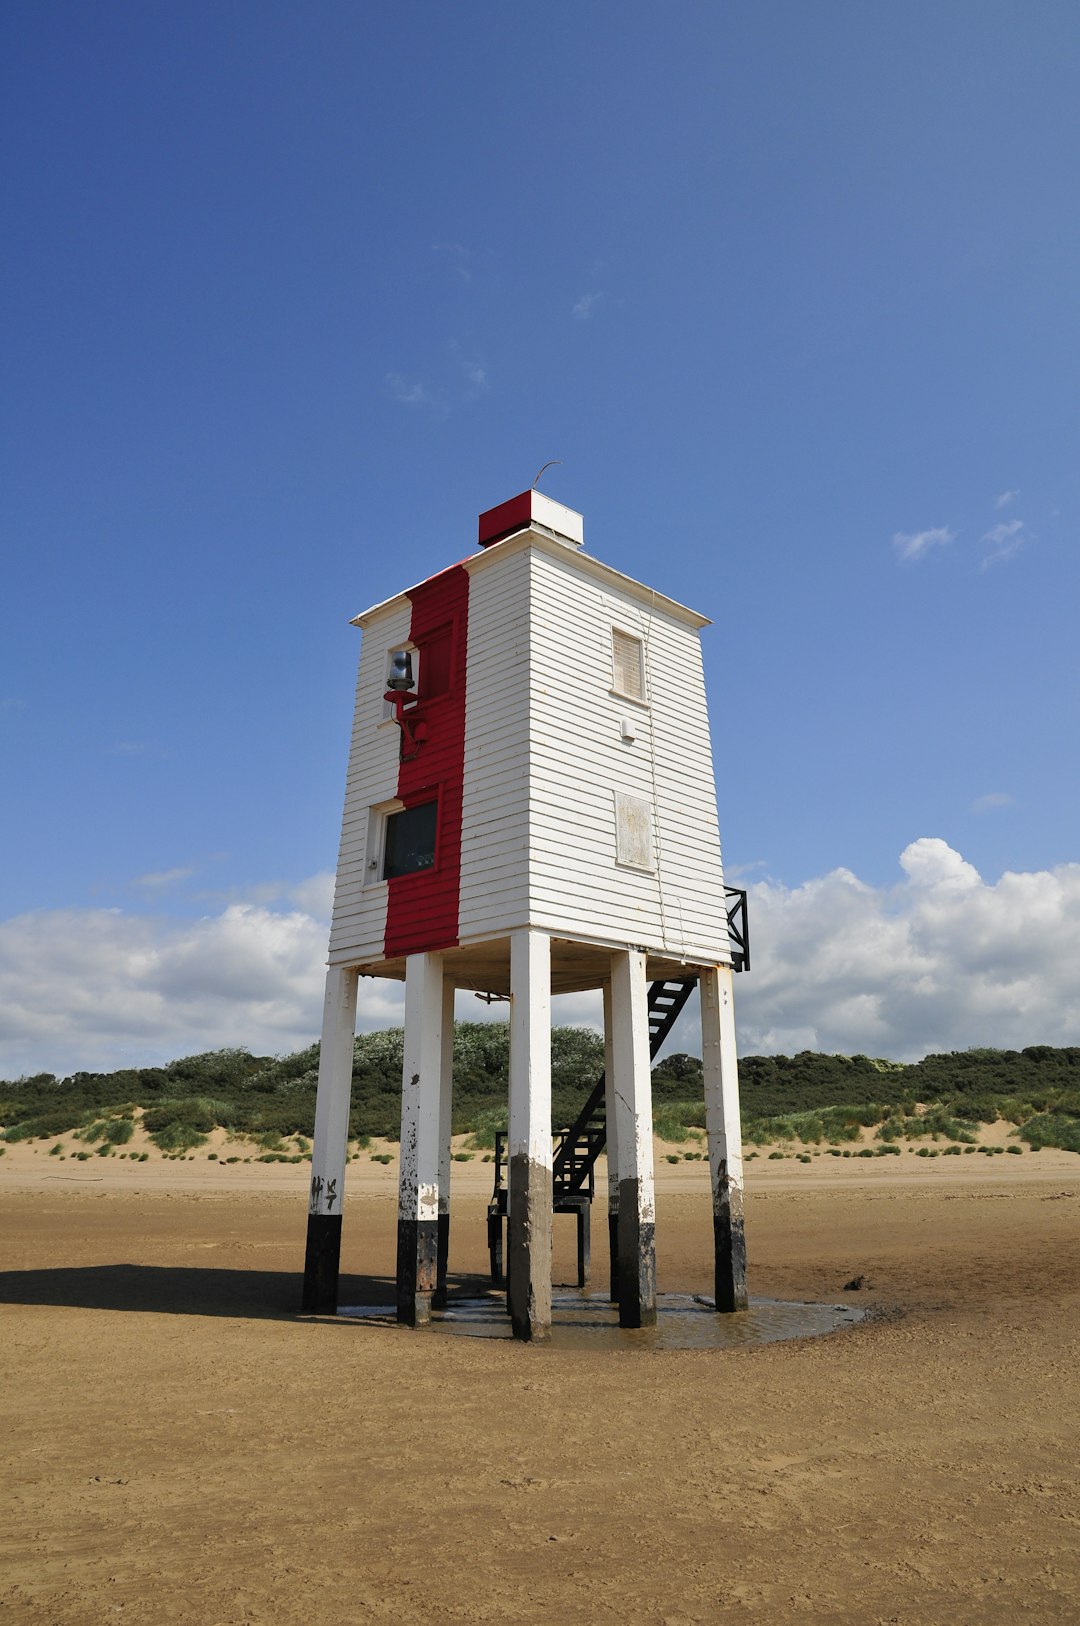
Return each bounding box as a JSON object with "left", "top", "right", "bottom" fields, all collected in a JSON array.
[{"left": 301, "top": 966, "right": 358, "bottom": 1315}]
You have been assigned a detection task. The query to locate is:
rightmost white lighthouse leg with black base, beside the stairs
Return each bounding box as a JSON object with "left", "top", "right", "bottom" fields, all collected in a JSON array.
[{"left": 701, "top": 966, "right": 747, "bottom": 1311}]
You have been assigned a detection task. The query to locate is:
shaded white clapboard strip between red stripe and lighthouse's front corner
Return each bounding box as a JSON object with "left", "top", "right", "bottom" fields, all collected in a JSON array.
[{"left": 459, "top": 551, "right": 530, "bottom": 941}]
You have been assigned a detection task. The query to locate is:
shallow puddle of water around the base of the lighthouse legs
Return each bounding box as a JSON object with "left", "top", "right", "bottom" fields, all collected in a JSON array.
[{"left": 338, "top": 1293, "right": 865, "bottom": 1350}]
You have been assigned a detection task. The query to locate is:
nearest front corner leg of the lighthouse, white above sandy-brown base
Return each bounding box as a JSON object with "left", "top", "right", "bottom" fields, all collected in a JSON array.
[{"left": 507, "top": 932, "right": 551, "bottom": 1338}]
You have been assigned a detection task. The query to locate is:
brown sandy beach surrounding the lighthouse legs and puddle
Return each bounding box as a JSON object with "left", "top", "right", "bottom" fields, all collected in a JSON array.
[{"left": 0, "top": 1148, "right": 1080, "bottom": 1626}]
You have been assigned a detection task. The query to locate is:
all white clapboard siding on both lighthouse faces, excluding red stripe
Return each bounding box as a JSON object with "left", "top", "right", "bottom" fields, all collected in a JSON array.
[{"left": 320, "top": 532, "right": 729, "bottom": 964}]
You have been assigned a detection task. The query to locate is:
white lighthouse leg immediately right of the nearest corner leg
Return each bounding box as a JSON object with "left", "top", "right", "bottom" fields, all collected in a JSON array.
[{"left": 612, "top": 948, "right": 655, "bottom": 1327}]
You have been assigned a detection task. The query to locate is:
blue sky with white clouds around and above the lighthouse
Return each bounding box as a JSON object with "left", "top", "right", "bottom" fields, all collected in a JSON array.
[{"left": 0, "top": 0, "right": 1080, "bottom": 1075}]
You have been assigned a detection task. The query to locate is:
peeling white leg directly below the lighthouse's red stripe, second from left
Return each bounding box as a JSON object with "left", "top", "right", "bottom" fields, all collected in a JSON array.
[{"left": 397, "top": 954, "right": 444, "bottom": 1327}]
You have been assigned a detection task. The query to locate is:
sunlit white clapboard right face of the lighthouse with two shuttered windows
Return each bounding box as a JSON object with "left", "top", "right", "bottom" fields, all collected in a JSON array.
[{"left": 529, "top": 550, "right": 727, "bottom": 959}]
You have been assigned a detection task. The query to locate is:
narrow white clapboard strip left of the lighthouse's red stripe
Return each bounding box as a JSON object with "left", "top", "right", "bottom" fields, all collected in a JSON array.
[{"left": 330, "top": 600, "right": 412, "bottom": 966}]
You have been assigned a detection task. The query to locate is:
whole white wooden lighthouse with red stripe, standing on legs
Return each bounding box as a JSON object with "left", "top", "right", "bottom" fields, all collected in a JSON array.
[{"left": 304, "top": 491, "right": 747, "bottom": 1338}]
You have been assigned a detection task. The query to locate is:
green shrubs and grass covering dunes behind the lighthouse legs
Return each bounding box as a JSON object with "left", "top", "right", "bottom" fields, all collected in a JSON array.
[{"left": 0, "top": 1023, "right": 1080, "bottom": 1158}]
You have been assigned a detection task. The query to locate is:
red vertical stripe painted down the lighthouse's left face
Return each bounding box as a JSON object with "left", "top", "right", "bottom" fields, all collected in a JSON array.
[{"left": 384, "top": 564, "right": 468, "bottom": 959}]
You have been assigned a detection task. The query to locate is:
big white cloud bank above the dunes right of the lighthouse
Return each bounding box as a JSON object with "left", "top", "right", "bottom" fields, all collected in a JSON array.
[{"left": 728, "top": 836, "right": 1080, "bottom": 1060}]
